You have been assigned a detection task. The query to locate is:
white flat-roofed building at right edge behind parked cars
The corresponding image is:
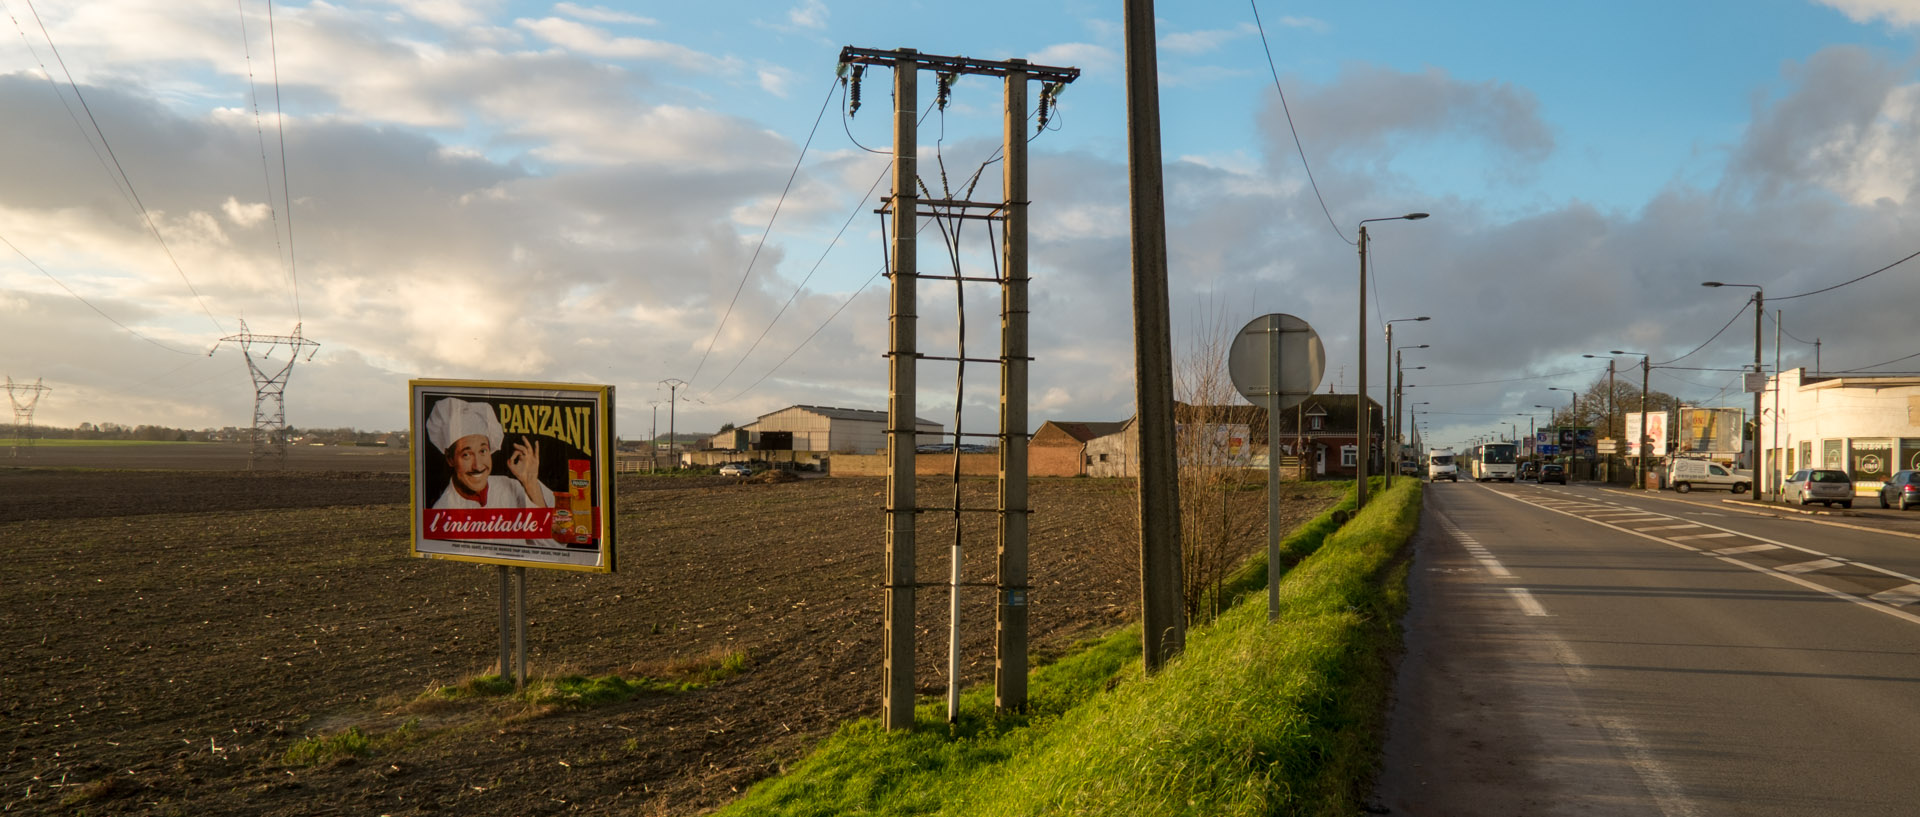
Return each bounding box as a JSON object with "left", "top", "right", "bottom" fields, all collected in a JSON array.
[{"left": 1761, "top": 368, "right": 1920, "bottom": 493}]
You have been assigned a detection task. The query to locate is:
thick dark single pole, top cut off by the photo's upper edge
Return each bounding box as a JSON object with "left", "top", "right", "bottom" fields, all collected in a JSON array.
[{"left": 1125, "top": 0, "right": 1182, "bottom": 673}]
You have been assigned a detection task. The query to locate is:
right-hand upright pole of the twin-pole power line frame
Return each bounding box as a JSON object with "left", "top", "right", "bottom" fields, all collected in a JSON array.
[{"left": 993, "top": 59, "right": 1027, "bottom": 710}]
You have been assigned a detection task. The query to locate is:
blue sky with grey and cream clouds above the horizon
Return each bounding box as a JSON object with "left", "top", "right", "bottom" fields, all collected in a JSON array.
[{"left": 0, "top": 0, "right": 1920, "bottom": 450}]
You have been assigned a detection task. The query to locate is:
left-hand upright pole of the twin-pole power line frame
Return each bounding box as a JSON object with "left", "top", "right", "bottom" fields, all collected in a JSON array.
[{"left": 881, "top": 50, "right": 920, "bottom": 729}]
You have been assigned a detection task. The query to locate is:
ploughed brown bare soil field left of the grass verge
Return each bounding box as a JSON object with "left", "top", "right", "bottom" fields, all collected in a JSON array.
[{"left": 0, "top": 456, "right": 1327, "bottom": 815}]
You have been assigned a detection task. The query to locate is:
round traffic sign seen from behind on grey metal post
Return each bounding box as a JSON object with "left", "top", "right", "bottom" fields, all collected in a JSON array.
[{"left": 1227, "top": 313, "right": 1327, "bottom": 621}]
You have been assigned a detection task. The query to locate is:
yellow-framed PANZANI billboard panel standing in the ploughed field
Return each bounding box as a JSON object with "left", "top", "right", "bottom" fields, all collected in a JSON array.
[{"left": 407, "top": 380, "right": 614, "bottom": 573}]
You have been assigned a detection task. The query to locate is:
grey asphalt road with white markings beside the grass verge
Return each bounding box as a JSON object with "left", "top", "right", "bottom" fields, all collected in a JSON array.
[{"left": 1375, "top": 483, "right": 1920, "bottom": 817}]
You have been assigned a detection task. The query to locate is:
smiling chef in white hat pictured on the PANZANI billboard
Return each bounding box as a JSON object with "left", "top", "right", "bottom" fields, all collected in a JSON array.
[{"left": 426, "top": 397, "right": 553, "bottom": 508}]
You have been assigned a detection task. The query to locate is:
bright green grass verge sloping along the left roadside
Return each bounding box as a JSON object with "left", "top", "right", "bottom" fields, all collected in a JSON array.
[{"left": 722, "top": 479, "right": 1421, "bottom": 815}]
